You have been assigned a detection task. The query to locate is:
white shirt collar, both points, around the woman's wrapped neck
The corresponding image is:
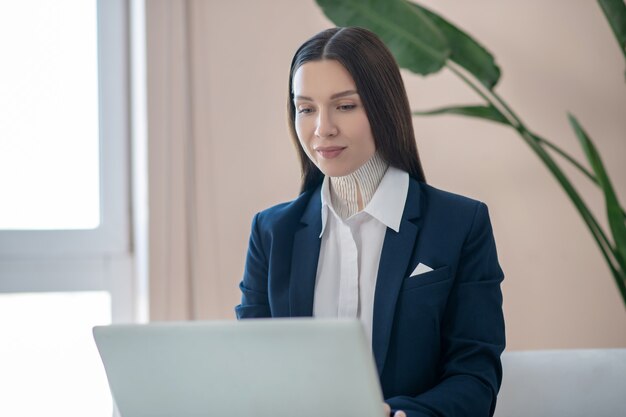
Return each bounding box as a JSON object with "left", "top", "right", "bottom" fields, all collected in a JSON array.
[{"left": 319, "top": 166, "right": 409, "bottom": 237}]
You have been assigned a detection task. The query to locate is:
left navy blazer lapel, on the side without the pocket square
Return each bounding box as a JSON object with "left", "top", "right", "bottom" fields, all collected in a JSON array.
[{"left": 289, "top": 188, "right": 322, "bottom": 317}]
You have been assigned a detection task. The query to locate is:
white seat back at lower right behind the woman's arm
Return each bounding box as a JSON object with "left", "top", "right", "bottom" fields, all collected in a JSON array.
[{"left": 494, "top": 349, "right": 626, "bottom": 417}]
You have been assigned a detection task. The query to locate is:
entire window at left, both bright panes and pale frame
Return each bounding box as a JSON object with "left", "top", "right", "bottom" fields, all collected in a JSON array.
[{"left": 0, "top": 0, "right": 134, "bottom": 417}]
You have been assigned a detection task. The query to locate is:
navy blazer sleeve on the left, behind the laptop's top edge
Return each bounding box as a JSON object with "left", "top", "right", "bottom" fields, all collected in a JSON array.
[{"left": 235, "top": 213, "right": 271, "bottom": 319}]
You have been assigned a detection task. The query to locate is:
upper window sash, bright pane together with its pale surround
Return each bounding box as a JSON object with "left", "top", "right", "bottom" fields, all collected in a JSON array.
[{"left": 0, "top": 0, "right": 128, "bottom": 257}]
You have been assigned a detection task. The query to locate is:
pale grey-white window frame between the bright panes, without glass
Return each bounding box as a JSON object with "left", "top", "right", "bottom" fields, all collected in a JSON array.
[{"left": 0, "top": 0, "right": 132, "bottom": 322}]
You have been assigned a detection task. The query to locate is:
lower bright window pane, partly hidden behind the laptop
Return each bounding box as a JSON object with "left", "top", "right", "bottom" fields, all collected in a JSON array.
[{"left": 0, "top": 291, "right": 113, "bottom": 417}]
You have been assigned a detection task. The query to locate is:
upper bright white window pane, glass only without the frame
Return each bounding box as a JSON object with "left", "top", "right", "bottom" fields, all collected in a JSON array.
[{"left": 0, "top": 0, "right": 100, "bottom": 230}]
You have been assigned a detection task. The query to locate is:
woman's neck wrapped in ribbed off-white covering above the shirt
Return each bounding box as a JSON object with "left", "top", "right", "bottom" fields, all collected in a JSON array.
[{"left": 330, "top": 152, "right": 389, "bottom": 220}]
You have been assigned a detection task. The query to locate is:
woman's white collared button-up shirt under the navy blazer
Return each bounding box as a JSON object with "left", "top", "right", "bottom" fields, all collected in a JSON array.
[{"left": 313, "top": 167, "right": 409, "bottom": 346}]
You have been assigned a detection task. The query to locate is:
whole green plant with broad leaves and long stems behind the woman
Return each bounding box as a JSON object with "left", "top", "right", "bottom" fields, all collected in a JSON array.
[{"left": 316, "top": 0, "right": 626, "bottom": 306}]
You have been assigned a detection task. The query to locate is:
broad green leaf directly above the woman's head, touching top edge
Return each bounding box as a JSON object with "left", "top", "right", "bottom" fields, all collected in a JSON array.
[{"left": 316, "top": 0, "right": 450, "bottom": 75}]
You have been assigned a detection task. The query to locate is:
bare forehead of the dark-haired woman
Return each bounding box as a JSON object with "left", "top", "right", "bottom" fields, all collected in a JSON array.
[{"left": 293, "top": 59, "right": 356, "bottom": 99}]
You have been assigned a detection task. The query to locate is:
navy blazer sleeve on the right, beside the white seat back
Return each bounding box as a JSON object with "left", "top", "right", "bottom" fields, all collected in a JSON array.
[{"left": 386, "top": 203, "right": 505, "bottom": 417}]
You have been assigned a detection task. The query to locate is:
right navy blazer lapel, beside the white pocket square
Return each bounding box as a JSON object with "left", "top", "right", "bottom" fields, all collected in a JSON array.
[{"left": 372, "top": 180, "right": 420, "bottom": 375}]
